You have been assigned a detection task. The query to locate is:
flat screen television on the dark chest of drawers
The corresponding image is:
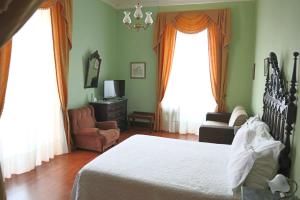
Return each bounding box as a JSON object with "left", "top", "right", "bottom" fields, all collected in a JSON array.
[{"left": 103, "top": 80, "right": 125, "bottom": 99}]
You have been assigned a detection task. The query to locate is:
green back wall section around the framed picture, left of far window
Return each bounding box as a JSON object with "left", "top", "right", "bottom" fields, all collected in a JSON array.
[{"left": 116, "top": 8, "right": 156, "bottom": 113}]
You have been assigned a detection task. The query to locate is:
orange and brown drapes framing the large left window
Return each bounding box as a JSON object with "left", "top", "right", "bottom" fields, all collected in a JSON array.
[{"left": 0, "top": 0, "right": 73, "bottom": 150}]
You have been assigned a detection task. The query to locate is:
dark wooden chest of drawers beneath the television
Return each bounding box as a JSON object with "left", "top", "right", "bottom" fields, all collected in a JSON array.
[{"left": 90, "top": 99, "right": 127, "bottom": 131}]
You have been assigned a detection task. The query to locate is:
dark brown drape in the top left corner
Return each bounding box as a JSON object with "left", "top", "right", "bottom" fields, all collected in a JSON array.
[{"left": 0, "top": 0, "right": 44, "bottom": 47}]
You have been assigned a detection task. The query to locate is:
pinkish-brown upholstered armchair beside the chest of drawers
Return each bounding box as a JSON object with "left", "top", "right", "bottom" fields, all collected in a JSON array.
[{"left": 69, "top": 106, "right": 120, "bottom": 152}]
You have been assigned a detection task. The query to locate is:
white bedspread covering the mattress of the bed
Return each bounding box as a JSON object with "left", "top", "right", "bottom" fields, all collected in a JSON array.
[{"left": 72, "top": 135, "right": 233, "bottom": 200}]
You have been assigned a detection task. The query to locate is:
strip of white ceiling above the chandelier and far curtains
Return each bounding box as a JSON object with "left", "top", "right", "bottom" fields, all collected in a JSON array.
[{"left": 102, "top": 0, "right": 252, "bottom": 9}]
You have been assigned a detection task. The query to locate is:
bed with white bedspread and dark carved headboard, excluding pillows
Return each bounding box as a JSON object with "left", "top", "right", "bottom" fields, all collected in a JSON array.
[{"left": 72, "top": 53, "right": 298, "bottom": 200}]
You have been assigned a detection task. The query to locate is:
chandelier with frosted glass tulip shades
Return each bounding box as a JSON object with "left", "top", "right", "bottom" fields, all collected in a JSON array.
[{"left": 123, "top": 1, "right": 153, "bottom": 30}]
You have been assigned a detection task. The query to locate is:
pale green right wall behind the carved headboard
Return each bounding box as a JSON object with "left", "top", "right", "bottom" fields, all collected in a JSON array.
[{"left": 252, "top": 0, "right": 300, "bottom": 195}]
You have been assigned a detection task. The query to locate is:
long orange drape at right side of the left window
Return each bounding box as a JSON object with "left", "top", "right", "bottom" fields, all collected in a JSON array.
[{"left": 51, "top": 0, "right": 73, "bottom": 151}]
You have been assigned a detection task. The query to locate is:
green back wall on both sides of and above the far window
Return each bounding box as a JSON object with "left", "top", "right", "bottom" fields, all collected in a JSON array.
[{"left": 117, "top": 1, "right": 255, "bottom": 115}]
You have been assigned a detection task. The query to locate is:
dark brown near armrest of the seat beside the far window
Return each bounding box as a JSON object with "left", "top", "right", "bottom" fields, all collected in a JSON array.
[{"left": 199, "top": 125, "right": 235, "bottom": 144}]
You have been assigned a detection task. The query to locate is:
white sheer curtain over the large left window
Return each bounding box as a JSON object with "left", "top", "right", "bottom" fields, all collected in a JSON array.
[{"left": 0, "top": 10, "right": 67, "bottom": 178}]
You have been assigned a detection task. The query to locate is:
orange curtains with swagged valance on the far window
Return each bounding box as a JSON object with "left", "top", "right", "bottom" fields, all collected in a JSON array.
[{"left": 153, "top": 9, "right": 231, "bottom": 130}]
